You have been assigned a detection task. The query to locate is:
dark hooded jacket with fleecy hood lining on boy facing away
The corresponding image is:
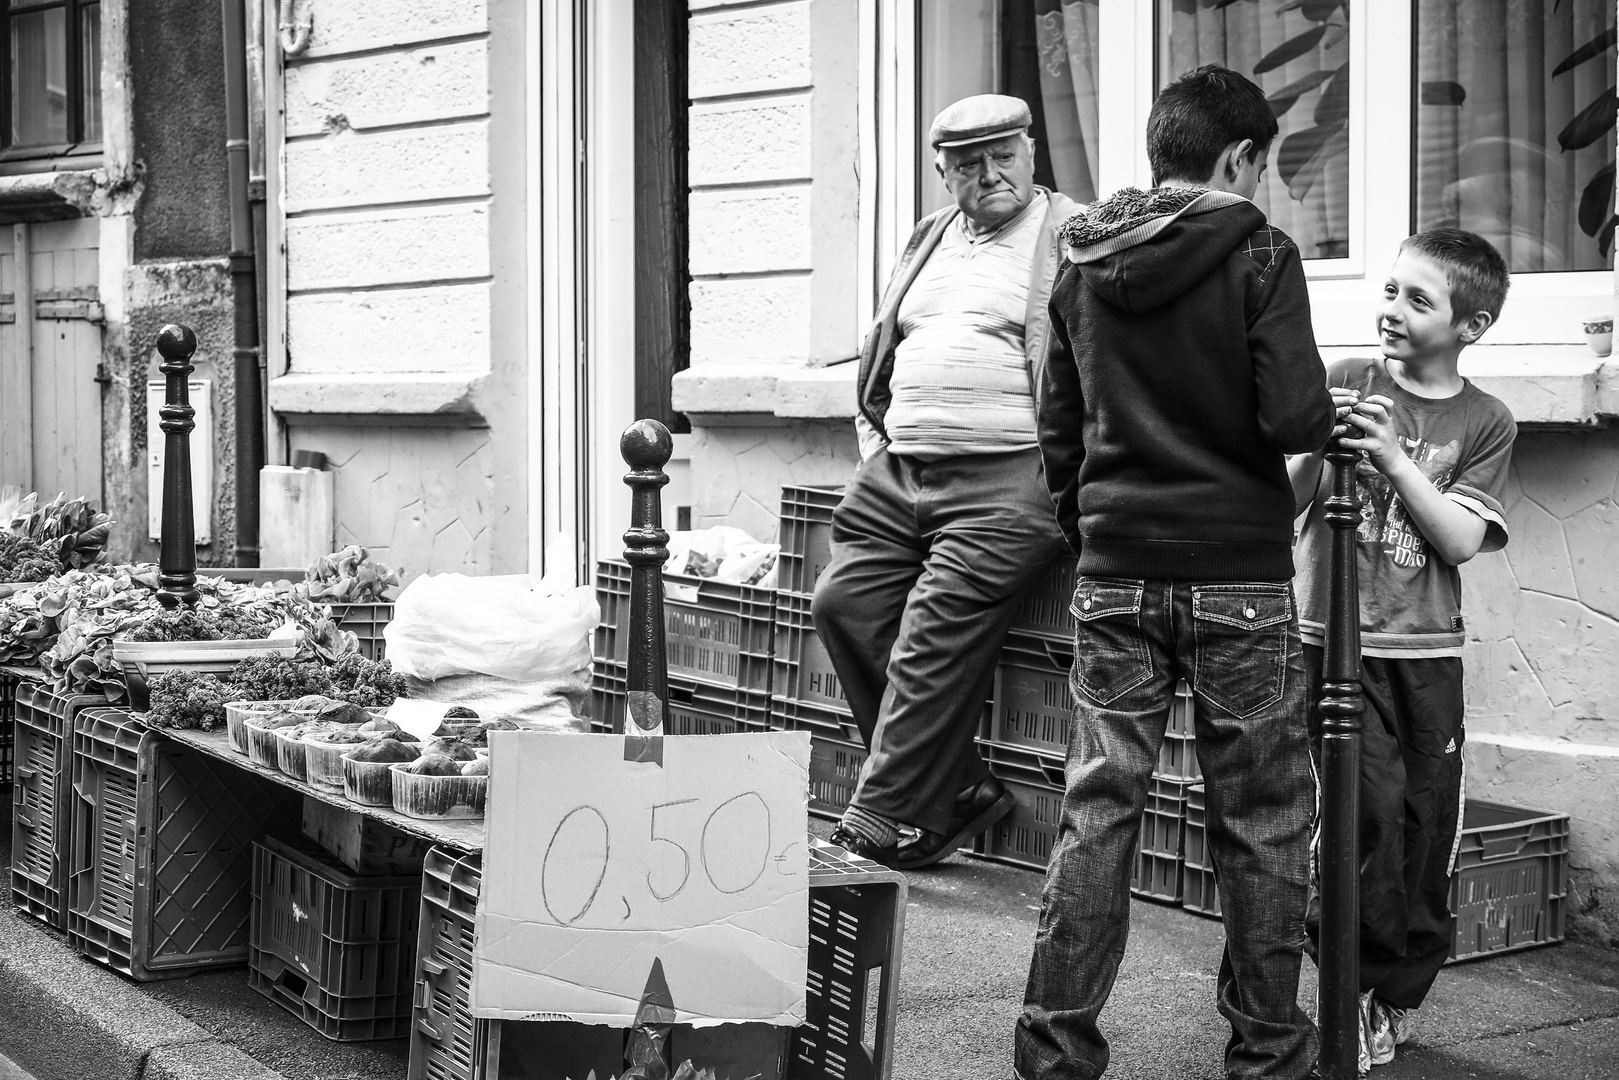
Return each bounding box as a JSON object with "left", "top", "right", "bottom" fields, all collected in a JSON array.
[{"left": 1036, "top": 188, "right": 1332, "bottom": 581}]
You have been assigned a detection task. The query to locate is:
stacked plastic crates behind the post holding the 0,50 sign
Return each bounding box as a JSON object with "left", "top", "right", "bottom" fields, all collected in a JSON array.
[{"left": 591, "top": 560, "right": 776, "bottom": 735}]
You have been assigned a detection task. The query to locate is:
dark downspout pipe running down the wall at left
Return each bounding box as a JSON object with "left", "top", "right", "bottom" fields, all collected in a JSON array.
[{"left": 220, "top": 0, "right": 264, "bottom": 567}]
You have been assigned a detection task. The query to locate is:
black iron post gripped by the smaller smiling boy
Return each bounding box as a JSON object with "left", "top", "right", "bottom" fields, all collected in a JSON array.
[{"left": 1319, "top": 440, "right": 1365, "bottom": 1080}]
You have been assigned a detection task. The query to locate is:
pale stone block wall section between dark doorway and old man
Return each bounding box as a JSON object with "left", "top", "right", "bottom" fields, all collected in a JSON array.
[{"left": 675, "top": 0, "right": 861, "bottom": 539}]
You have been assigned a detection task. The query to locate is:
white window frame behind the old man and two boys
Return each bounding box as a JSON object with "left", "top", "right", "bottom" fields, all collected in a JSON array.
[{"left": 880, "top": 0, "right": 1619, "bottom": 355}]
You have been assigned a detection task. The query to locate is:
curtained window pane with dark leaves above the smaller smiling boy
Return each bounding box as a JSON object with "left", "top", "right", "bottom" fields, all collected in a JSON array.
[{"left": 1412, "top": 0, "right": 1614, "bottom": 274}]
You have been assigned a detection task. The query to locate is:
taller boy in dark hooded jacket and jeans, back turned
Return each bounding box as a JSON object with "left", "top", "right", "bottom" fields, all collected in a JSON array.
[{"left": 1015, "top": 65, "right": 1334, "bottom": 1080}]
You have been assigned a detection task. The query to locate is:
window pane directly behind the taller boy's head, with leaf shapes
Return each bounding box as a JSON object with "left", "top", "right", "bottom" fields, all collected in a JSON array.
[{"left": 1158, "top": 0, "right": 1350, "bottom": 259}]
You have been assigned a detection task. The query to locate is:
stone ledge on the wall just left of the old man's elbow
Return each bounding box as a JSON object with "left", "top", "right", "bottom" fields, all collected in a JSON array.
[{"left": 674, "top": 363, "right": 858, "bottom": 426}]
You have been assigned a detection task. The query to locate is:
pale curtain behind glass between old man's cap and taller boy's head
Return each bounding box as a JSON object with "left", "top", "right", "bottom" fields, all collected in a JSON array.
[{"left": 1035, "top": 0, "right": 1098, "bottom": 202}]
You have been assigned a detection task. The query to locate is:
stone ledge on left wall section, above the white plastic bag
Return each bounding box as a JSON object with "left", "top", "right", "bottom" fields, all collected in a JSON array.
[{"left": 270, "top": 372, "right": 486, "bottom": 427}]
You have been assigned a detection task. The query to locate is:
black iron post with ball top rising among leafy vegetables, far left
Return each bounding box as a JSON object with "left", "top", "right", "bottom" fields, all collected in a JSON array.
[{"left": 157, "top": 322, "right": 198, "bottom": 607}]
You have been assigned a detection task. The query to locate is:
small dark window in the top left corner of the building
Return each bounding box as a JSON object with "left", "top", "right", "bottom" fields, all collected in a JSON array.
[{"left": 0, "top": 0, "right": 100, "bottom": 157}]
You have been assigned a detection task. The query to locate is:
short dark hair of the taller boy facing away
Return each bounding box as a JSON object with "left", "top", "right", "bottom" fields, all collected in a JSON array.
[{"left": 1146, "top": 63, "right": 1281, "bottom": 185}]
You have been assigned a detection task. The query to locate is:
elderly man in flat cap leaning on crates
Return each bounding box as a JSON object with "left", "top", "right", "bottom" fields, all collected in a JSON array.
[{"left": 813, "top": 94, "right": 1078, "bottom": 870}]
